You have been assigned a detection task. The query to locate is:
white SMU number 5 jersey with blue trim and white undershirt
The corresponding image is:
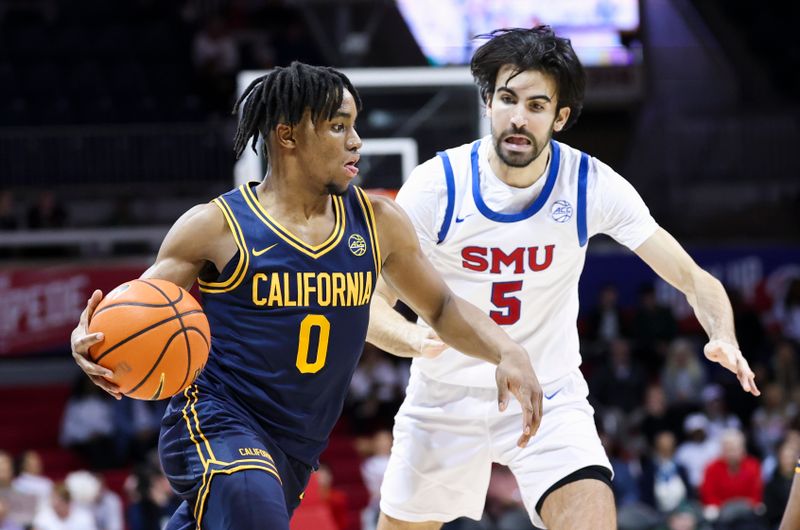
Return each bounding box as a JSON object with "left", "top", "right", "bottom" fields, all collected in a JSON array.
[{"left": 397, "top": 137, "right": 658, "bottom": 387}]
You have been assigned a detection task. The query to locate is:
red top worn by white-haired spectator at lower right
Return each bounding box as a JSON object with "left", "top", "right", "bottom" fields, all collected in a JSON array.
[{"left": 700, "top": 456, "right": 763, "bottom": 506}]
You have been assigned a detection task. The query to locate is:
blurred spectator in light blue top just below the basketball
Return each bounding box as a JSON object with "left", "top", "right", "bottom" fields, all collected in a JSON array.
[{"left": 59, "top": 374, "right": 121, "bottom": 469}]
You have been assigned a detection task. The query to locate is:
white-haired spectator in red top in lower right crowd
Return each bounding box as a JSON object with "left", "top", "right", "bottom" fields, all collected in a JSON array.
[{"left": 700, "top": 429, "right": 763, "bottom": 507}]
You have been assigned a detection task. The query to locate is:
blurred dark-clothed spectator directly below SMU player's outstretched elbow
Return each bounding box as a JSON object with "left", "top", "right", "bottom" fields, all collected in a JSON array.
[{"left": 631, "top": 284, "right": 677, "bottom": 373}]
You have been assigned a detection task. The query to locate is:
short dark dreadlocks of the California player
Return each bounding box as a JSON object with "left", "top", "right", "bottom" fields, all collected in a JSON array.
[{"left": 228, "top": 61, "right": 361, "bottom": 158}]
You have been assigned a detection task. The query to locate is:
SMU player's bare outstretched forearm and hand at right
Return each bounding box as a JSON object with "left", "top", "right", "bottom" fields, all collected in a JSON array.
[{"left": 635, "top": 228, "right": 761, "bottom": 396}]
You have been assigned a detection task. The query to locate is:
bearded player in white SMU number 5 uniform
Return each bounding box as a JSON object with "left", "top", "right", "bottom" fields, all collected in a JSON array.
[{"left": 369, "top": 26, "right": 759, "bottom": 530}]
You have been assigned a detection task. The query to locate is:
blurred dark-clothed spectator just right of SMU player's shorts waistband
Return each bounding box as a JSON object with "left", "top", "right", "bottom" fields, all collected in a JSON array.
[{"left": 591, "top": 339, "right": 647, "bottom": 413}]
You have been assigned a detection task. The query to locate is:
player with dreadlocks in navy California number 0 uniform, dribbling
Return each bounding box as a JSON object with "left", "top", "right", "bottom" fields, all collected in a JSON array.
[{"left": 72, "top": 63, "right": 541, "bottom": 530}]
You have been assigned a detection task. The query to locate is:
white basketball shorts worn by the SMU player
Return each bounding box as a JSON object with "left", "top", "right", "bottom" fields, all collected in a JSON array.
[{"left": 381, "top": 369, "right": 611, "bottom": 528}]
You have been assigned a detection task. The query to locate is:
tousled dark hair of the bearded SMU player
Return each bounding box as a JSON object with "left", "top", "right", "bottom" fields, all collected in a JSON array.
[{"left": 470, "top": 26, "right": 586, "bottom": 129}]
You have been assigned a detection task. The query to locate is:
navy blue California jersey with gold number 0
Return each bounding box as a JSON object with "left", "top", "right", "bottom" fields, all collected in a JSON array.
[{"left": 197, "top": 183, "right": 381, "bottom": 465}]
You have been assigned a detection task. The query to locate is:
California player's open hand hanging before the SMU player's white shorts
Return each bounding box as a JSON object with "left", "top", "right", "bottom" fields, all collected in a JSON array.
[{"left": 495, "top": 348, "right": 542, "bottom": 447}]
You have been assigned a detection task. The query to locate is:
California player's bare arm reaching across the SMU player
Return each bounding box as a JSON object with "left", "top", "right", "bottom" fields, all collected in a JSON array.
[{"left": 372, "top": 192, "right": 542, "bottom": 447}]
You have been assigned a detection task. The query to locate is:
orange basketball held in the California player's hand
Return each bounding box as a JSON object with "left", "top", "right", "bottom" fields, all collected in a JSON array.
[{"left": 89, "top": 279, "right": 211, "bottom": 400}]
